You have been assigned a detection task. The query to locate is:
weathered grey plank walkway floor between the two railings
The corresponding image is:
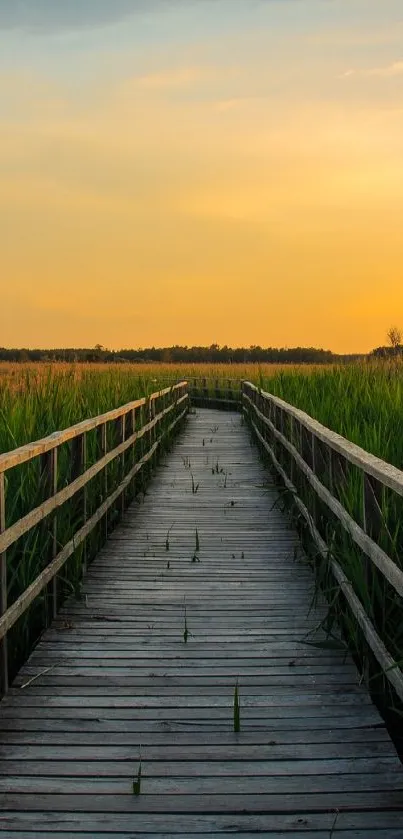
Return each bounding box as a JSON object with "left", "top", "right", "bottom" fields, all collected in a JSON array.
[{"left": 0, "top": 410, "right": 403, "bottom": 839}]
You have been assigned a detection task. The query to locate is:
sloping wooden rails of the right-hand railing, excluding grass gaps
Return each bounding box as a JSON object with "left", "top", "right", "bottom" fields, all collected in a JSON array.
[{"left": 242, "top": 382, "right": 403, "bottom": 701}]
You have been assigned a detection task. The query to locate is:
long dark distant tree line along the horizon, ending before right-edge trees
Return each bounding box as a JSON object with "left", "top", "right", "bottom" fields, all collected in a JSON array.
[{"left": 0, "top": 344, "right": 348, "bottom": 364}]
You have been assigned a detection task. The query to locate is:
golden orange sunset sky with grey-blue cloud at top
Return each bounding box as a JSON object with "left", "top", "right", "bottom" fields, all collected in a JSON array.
[{"left": 0, "top": 0, "right": 403, "bottom": 352}]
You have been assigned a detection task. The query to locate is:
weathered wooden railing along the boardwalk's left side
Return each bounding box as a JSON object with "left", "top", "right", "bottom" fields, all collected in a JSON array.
[{"left": 0, "top": 382, "right": 189, "bottom": 694}]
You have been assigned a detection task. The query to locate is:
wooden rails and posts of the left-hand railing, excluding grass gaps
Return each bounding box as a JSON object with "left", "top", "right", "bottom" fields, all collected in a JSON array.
[{"left": 0, "top": 381, "right": 189, "bottom": 693}]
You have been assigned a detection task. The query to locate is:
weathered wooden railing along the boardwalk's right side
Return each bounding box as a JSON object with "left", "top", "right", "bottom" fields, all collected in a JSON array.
[{"left": 242, "top": 382, "right": 403, "bottom": 701}]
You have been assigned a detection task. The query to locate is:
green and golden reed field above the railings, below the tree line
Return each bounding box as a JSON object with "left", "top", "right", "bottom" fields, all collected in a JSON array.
[{"left": 0, "top": 362, "right": 403, "bottom": 468}]
